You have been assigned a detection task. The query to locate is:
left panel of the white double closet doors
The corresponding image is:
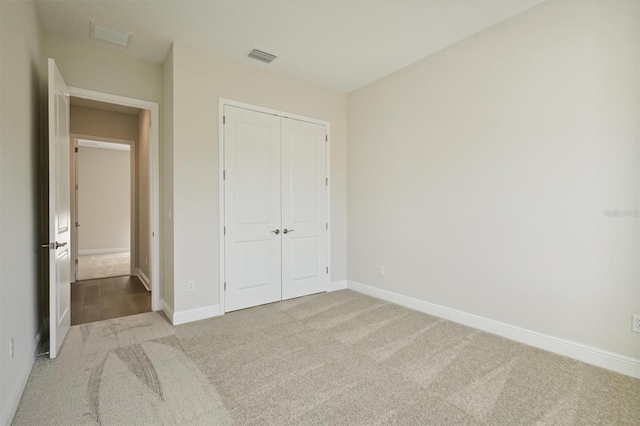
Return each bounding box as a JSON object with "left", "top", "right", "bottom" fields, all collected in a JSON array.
[{"left": 224, "top": 106, "right": 282, "bottom": 311}]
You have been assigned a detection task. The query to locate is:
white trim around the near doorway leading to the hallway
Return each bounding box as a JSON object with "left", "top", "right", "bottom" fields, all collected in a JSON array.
[{"left": 69, "top": 87, "right": 162, "bottom": 311}]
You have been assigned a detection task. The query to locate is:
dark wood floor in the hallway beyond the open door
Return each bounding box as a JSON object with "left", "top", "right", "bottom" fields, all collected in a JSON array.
[{"left": 71, "top": 276, "right": 151, "bottom": 325}]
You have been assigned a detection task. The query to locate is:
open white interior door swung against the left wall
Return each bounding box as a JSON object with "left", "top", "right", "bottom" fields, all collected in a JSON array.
[{"left": 48, "top": 59, "right": 71, "bottom": 358}]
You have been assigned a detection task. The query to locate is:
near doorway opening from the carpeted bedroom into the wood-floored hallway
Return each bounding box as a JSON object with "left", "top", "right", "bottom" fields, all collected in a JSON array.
[{"left": 70, "top": 93, "right": 154, "bottom": 325}]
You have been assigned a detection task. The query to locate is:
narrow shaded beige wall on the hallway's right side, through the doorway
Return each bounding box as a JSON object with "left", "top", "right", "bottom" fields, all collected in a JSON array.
[{"left": 134, "top": 110, "right": 152, "bottom": 278}]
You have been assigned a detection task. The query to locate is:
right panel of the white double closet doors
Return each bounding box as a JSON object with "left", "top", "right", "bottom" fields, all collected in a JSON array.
[{"left": 281, "top": 118, "right": 329, "bottom": 300}]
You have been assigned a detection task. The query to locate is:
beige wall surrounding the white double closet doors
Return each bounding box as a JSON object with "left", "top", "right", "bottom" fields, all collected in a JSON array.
[{"left": 165, "top": 43, "right": 347, "bottom": 312}]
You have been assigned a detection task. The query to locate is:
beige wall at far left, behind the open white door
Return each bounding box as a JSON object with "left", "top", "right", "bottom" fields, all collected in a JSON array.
[{"left": 0, "top": 1, "right": 42, "bottom": 424}]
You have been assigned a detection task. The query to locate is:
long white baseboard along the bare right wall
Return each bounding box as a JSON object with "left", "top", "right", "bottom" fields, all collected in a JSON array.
[{"left": 347, "top": 281, "right": 640, "bottom": 378}]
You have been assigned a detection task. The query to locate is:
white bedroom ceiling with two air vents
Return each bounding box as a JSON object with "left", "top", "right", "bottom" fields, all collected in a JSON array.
[{"left": 37, "top": 0, "right": 544, "bottom": 92}]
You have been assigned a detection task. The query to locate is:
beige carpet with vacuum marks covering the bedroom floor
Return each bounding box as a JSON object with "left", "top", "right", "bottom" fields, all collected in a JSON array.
[{"left": 14, "top": 290, "right": 640, "bottom": 425}]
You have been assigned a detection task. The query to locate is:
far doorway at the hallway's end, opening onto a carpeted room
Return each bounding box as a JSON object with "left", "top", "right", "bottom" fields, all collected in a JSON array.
[{"left": 72, "top": 138, "right": 132, "bottom": 281}]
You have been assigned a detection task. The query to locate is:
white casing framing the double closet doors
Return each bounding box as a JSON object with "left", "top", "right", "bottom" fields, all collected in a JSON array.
[{"left": 218, "top": 98, "right": 332, "bottom": 315}]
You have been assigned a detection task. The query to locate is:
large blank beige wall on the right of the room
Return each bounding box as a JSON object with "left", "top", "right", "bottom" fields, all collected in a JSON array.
[{"left": 348, "top": 2, "right": 640, "bottom": 359}]
